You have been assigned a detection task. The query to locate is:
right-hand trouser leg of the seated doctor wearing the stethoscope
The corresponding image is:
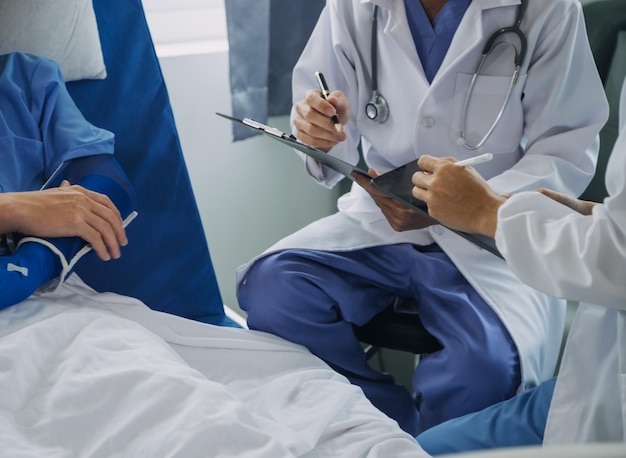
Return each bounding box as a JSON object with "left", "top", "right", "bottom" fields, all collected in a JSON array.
[{"left": 402, "top": 245, "right": 521, "bottom": 431}]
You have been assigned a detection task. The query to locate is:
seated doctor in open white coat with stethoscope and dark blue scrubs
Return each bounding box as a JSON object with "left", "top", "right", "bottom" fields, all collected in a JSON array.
[{"left": 237, "top": 0, "right": 608, "bottom": 433}]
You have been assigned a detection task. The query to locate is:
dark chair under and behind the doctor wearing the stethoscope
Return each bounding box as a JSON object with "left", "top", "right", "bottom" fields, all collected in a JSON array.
[{"left": 353, "top": 0, "right": 626, "bottom": 358}]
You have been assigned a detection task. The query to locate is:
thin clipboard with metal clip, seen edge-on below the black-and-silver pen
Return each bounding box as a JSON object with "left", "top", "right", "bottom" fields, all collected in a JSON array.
[{"left": 215, "top": 113, "right": 372, "bottom": 180}]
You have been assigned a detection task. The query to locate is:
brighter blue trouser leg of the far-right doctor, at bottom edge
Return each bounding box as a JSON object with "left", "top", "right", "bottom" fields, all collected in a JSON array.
[{"left": 417, "top": 378, "right": 556, "bottom": 456}]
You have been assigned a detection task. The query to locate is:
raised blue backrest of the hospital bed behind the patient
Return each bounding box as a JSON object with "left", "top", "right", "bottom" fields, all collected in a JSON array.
[{"left": 67, "top": 0, "right": 237, "bottom": 326}]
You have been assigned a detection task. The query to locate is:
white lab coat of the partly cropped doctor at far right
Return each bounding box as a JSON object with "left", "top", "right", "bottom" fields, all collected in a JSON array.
[{"left": 496, "top": 79, "right": 626, "bottom": 444}]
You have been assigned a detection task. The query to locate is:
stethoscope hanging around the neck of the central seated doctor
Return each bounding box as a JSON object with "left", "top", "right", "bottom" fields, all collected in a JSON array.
[{"left": 365, "top": 0, "right": 528, "bottom": 150}]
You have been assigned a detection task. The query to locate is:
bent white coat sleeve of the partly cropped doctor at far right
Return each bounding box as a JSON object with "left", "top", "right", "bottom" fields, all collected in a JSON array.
[{"left": 496, "top": 192, "right": 626, "bottom": 308}]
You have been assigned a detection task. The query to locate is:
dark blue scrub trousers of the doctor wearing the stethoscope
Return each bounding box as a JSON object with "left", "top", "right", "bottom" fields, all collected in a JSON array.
[{"left": 238, "top": 244, "right": 520, "bottom": 436}]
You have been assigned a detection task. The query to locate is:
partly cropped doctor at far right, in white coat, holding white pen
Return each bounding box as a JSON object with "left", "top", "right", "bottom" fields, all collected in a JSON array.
[{"left": 413, "top": 74, "right": 626, "bottom": 450}]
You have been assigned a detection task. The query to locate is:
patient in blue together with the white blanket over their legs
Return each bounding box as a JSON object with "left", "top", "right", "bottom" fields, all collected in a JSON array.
[{"left": 0, "top": 54, "right": 425, "bottom": 458}]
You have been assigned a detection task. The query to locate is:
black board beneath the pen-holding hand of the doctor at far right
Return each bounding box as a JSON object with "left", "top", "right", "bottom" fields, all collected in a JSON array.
[{"left": 371, "top": 159, "right": 503, "bottom": 258}]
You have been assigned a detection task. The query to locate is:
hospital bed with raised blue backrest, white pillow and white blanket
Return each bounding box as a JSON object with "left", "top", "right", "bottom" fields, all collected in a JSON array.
[{"left": 0, "top": 0, "right": 421, "bottom": 458}]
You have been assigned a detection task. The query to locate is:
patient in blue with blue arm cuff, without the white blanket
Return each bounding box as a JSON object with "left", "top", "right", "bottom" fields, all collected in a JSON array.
[{"left": 0, "top": 53, "right": 134, "bottom": 308}]
